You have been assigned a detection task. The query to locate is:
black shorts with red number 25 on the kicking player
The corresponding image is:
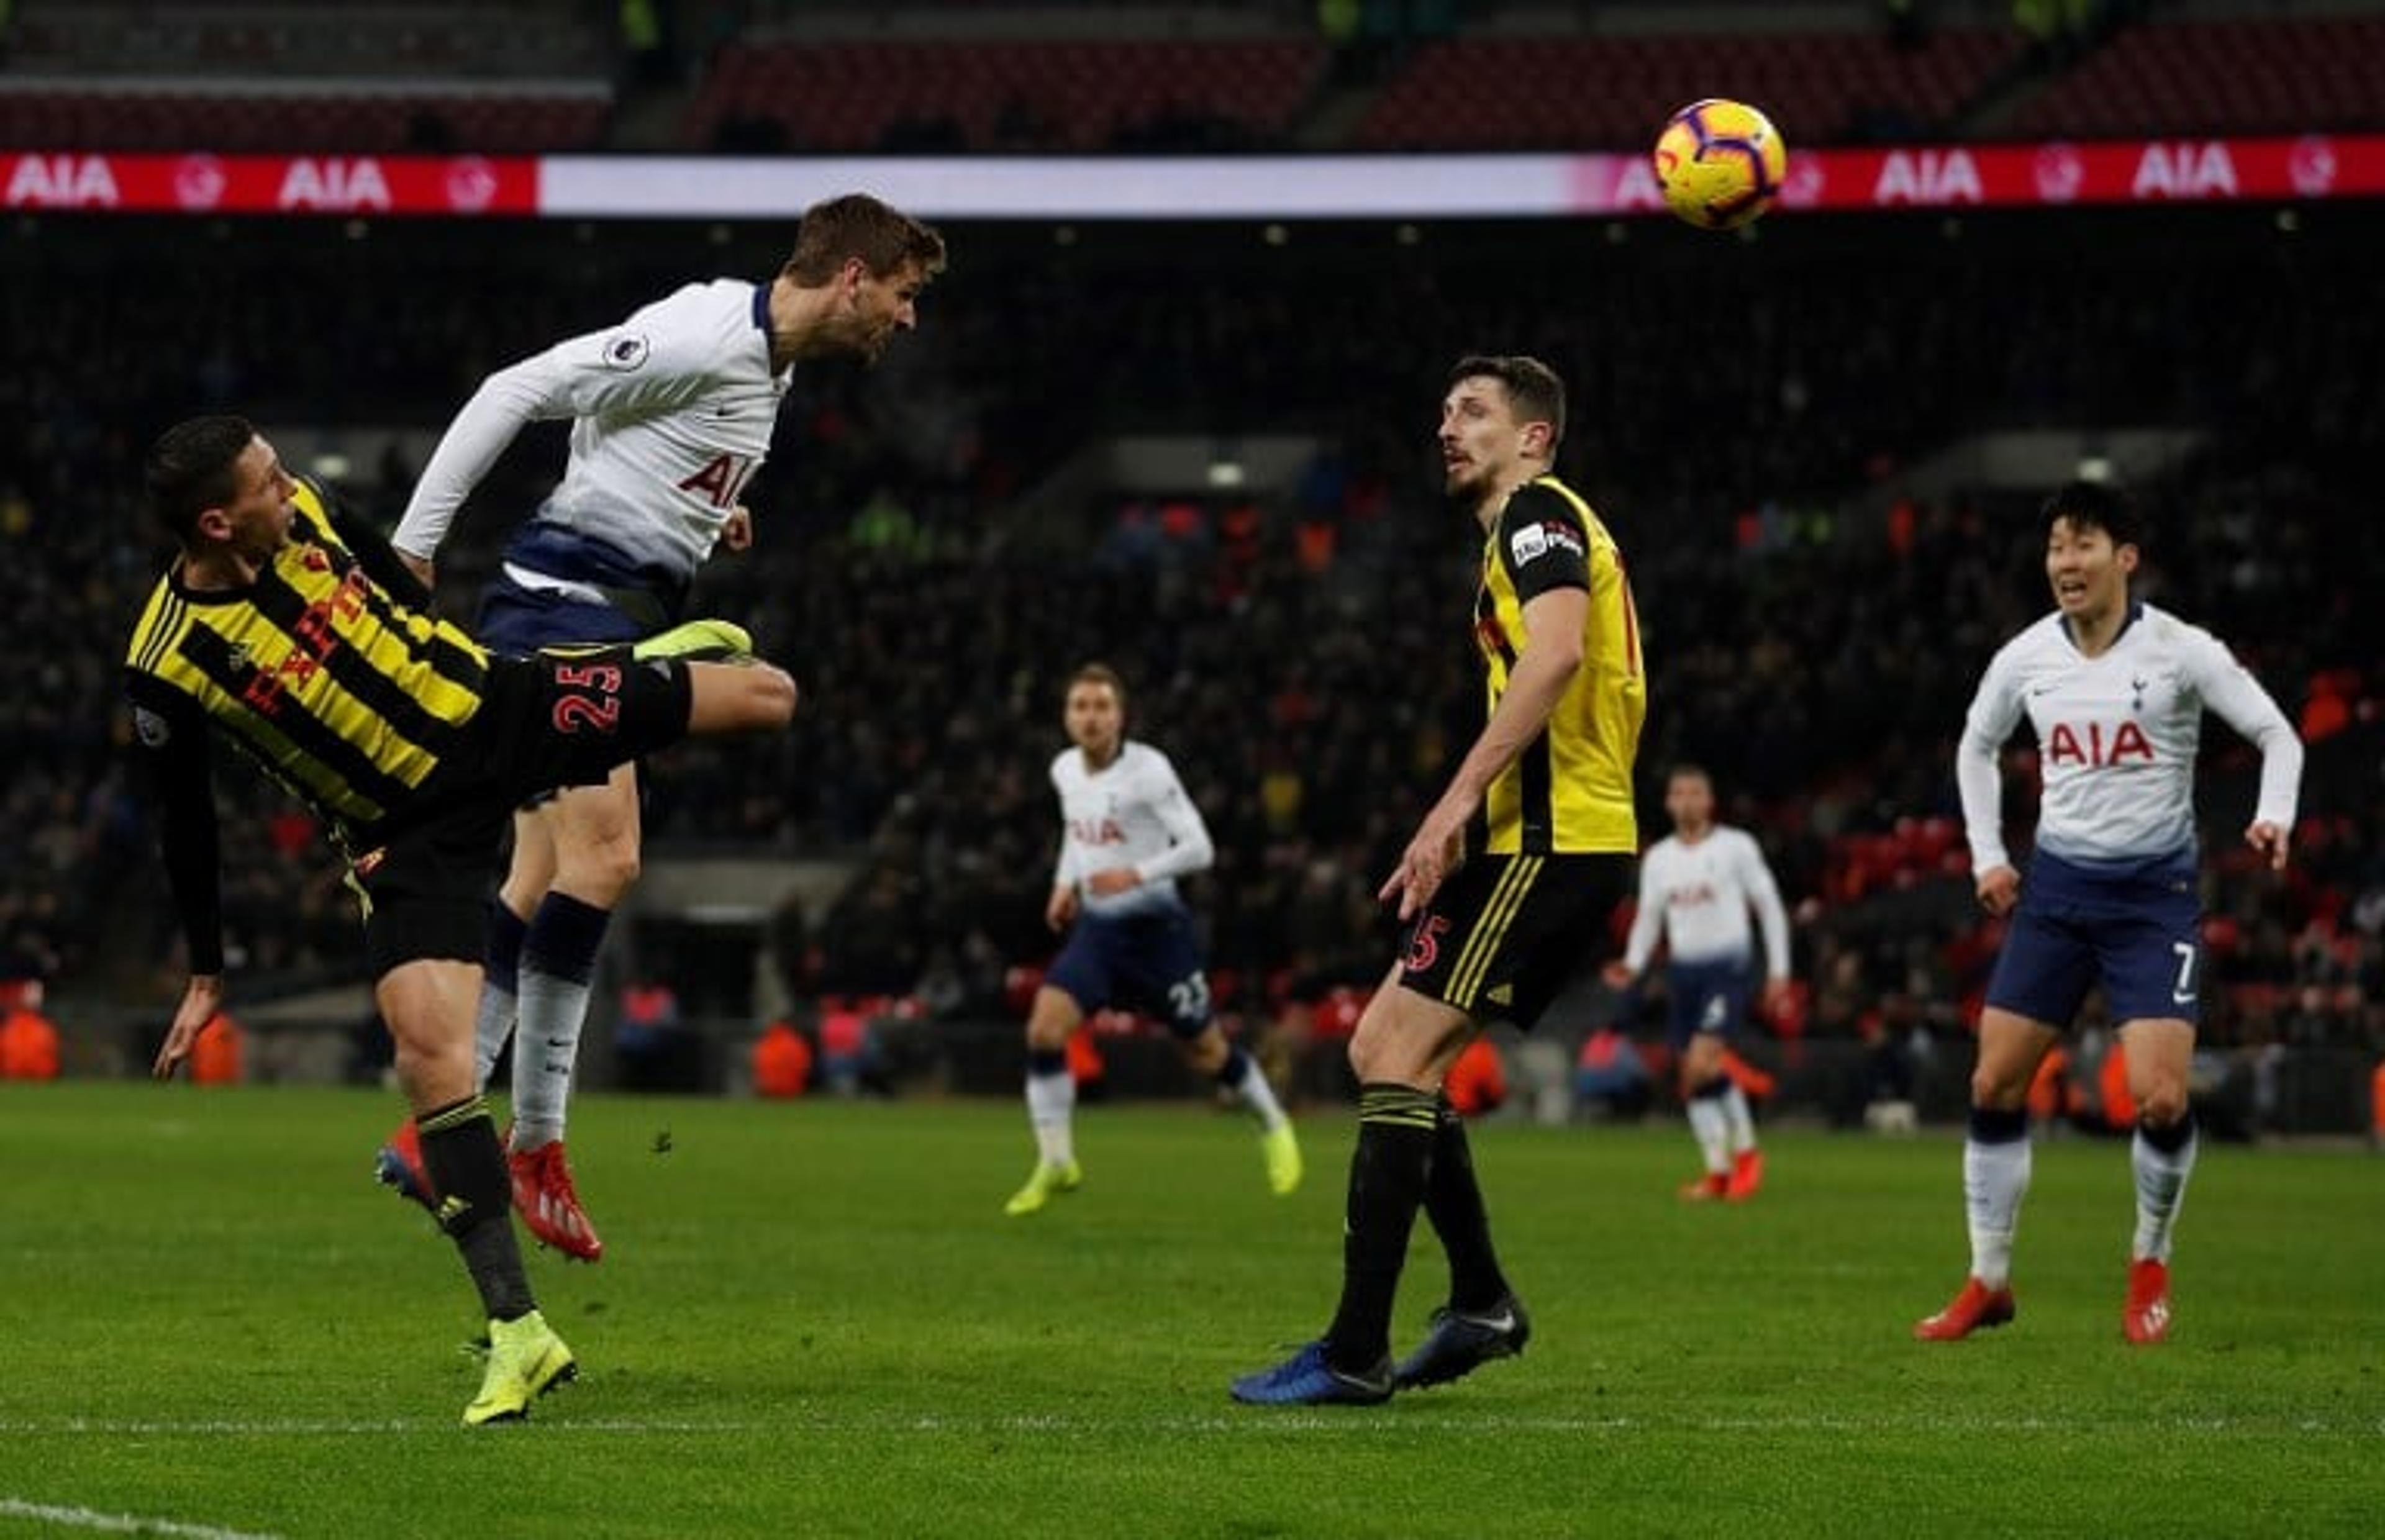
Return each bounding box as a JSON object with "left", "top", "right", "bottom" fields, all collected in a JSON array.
[{"left": 355, "top": 646, "right": 692, "bottom": 977}]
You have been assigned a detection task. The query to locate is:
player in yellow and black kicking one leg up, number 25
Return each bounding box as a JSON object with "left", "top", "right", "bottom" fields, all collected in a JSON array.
[{"left": 127, "top": 417, "right": 794, "bottom": 1423}]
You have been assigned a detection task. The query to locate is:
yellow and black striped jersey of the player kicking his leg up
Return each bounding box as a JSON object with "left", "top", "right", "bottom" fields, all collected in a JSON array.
[{"left": 124, "top": 481, "right": 489, "bottom": 841}]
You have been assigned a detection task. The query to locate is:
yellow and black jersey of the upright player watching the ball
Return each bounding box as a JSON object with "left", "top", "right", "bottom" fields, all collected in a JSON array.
[{"left": 1469, "top": 477, "right": 1648, "bottom": 856}]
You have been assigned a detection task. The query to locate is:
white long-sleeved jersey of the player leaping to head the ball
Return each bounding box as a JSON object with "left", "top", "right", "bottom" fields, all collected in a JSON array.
[{"left": 391, "top": 279, "right": 792, "bottom": 577}]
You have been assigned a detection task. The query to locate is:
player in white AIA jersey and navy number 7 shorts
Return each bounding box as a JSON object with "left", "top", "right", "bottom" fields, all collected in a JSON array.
[{"left": 1913, "top": 481, "right": 2302, "bottom": 1344}]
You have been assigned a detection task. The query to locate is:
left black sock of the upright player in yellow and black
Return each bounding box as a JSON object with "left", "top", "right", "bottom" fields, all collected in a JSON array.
[{"left": 1326, "top": 1085, "right": 1438, "bottom": 1370}]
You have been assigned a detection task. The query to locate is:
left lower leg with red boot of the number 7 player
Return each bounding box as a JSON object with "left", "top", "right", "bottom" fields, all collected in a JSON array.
[{"left": 1913, "top": 1006, "right": 2053, "bottom": 1342}]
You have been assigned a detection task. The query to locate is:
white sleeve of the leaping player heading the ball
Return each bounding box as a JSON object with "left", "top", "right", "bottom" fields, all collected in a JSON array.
[{"left": 389, "top": 312, "right": 716, "bottom": 560}]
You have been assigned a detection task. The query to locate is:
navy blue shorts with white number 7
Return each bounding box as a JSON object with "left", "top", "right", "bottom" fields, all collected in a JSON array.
[{"left": 1987, "top": 851, "right": 2204, "bottom": 1028}]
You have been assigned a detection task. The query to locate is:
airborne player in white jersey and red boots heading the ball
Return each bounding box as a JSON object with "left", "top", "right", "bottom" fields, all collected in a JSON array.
[{"left": 379, "top": 193, "right": 945, "bottom": 1261}]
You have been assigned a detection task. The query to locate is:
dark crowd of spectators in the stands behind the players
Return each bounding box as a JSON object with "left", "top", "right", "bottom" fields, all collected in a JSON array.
[{"left": 0, "top": 215, "right": 2385, "bottom": 1087}]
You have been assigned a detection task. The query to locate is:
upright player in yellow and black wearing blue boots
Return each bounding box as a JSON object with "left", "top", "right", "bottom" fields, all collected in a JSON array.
[{"left": 1233, "top": 358, "right": 1648, "bottom": 1404}]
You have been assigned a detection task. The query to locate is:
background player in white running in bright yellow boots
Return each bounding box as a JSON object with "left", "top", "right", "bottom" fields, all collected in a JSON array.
[{"left": 1004, "top": 663, "right": 1300, "bottom": 1218}]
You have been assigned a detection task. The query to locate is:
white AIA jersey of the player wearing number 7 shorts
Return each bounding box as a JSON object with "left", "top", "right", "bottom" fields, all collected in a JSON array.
[{"left": 1956, "top": 605, "right": 2302, "bottom": 872}]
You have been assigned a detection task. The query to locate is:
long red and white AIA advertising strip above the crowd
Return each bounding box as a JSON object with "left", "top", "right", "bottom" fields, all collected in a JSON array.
[{"left": 0, "top": 134, "right": 2385, "bottom": 219}]
